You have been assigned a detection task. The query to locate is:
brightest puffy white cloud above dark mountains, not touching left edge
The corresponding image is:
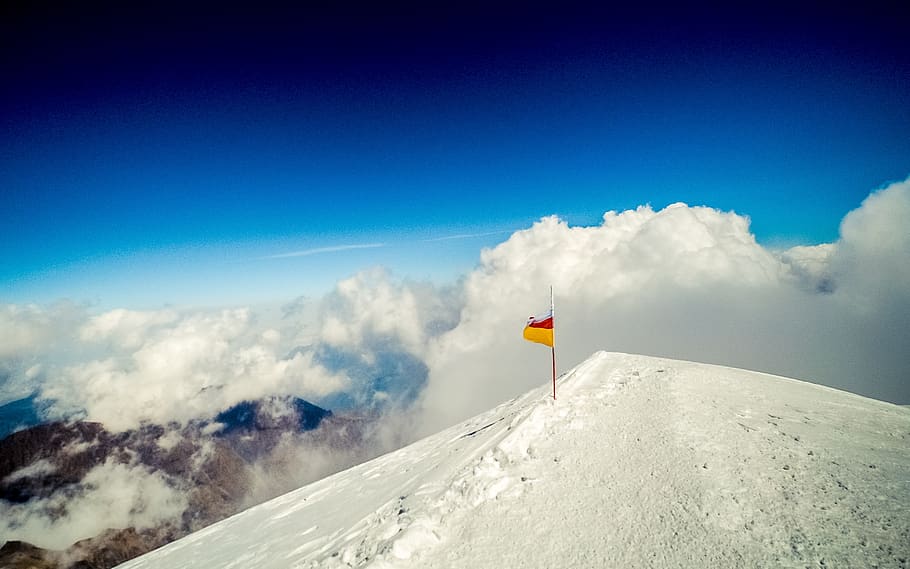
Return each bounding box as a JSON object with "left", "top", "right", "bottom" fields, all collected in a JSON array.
[{"left": 41, "top": 309, "right": 345, "bottom": 431}]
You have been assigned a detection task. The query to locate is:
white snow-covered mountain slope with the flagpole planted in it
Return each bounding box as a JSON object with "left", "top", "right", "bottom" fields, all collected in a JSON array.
[{"left": 122, "top": 352, "right": 910, "bottom": 569}]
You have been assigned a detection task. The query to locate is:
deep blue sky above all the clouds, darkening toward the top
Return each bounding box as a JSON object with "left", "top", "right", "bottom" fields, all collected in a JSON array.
[{"left": 0, "top": 2, "right": 910, "bottom": 306}]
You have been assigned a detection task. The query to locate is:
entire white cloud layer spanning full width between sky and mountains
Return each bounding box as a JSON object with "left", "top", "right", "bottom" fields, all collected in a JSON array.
[{"left": 0, "top": 176, "right": 910, "bottom": 431}]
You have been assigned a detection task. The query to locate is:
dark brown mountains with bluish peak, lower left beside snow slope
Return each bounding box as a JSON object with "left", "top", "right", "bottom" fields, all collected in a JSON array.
[{"left": 0, "top": 397, "right": 373, "bottom": 569}]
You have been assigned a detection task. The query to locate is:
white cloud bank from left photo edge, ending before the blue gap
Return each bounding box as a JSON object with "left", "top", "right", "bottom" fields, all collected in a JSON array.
[{"left": 0, "top": 305, "right": 347, "bottom": 431}]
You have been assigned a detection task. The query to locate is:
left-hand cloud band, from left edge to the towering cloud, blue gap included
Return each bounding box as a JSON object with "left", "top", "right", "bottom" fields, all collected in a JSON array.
[{"left": 0, "top": 269, "right": 459, "bottom": 431}]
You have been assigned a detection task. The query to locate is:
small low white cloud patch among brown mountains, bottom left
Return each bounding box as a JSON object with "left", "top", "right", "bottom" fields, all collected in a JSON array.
[{"left": 0, "top": 460, "right": 187, "bottom": 550}]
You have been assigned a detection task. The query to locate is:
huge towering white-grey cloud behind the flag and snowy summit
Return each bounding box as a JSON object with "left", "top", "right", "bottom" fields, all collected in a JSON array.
[{"left": 421, "top": 176, "right": 910, "bottom": 431}]
